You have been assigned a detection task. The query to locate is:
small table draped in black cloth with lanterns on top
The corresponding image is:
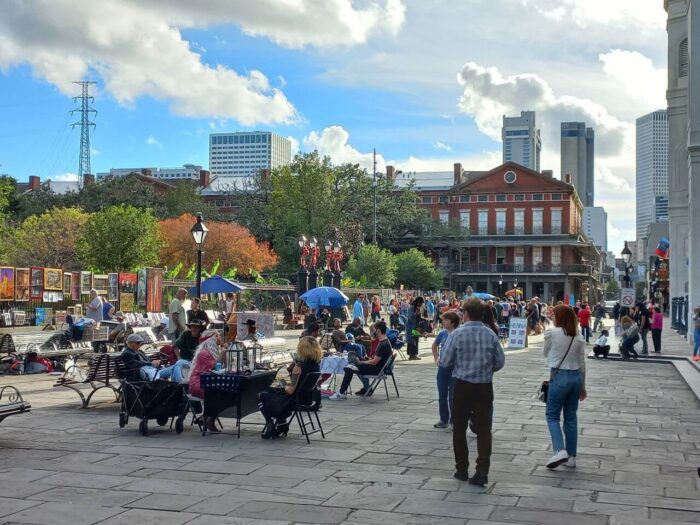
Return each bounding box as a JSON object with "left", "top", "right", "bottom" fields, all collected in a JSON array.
[{"left": 202, "top": 370, "right": 277, "bottom": 438}]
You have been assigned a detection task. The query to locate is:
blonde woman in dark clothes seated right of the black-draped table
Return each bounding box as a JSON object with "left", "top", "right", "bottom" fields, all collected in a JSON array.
[{"left": 258, "top": 337, "right": 323, "bottom": 439}]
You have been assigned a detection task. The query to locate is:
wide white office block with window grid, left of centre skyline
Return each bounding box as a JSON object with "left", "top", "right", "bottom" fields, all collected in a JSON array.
[{"left": 209, "top": 131, "right": 292, "bottom": 177}]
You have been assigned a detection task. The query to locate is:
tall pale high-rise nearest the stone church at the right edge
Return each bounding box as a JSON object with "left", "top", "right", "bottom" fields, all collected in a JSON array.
[{"left": 636, "top": 110, "right": 668, "bottom": 244}]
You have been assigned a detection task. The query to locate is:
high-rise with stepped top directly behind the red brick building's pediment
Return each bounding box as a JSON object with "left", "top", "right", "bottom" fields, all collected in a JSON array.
[{"left": 501, "top": 111, "right": 542, "bottom": 171}]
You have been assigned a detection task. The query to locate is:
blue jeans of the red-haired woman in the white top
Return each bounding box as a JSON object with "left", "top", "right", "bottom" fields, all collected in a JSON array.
[{"left": 546, "top": 369, "right": 582, "bottom": 457}]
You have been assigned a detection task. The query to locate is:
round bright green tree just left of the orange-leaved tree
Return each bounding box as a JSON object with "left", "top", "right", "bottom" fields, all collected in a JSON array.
[{"left": 77, "top": 206, "right": 163, "bottom": 272}]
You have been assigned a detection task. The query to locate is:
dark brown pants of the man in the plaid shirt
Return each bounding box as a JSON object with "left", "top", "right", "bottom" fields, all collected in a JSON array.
[{"left": 452, "top": 379, "right": 493, "bottom": 475}]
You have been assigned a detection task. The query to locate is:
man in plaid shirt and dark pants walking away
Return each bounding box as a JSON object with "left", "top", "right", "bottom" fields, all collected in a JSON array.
[{"left": 442, "top": 297, "right": 505, "bottom": 485}]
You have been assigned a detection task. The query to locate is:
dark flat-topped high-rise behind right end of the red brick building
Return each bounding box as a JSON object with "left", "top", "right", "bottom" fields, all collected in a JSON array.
[{"left": 561, "top": 122, "right": 595, "bottom": 207}]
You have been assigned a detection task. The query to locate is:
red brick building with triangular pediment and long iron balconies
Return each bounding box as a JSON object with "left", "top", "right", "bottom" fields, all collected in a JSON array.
[{"left": 404, "top": 162, "right": 600, "bottom": 301}]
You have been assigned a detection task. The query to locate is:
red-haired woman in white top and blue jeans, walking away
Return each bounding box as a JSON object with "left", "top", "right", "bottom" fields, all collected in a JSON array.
[{"left": 544, "top": 304, "right": 587, "bottom": 469}]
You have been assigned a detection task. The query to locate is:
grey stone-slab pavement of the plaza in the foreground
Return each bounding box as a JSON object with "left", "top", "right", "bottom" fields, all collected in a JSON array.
[{"left": 0, "top": 326, "right": 700, "bottom": 525}]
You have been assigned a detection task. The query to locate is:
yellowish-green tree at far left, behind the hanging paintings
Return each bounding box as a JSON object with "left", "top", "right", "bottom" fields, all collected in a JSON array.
[{"left": 10, "top": 208, "right": 90, "bottom": 270}]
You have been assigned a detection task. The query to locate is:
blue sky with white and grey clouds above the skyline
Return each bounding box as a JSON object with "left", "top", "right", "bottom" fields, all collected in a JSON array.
[{"left": 0, "top": 0, "right": 667, "bottom": 253}]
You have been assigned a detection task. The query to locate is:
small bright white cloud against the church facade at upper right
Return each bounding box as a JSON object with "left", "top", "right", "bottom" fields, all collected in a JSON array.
[{"left": 598, "top": 49, "right": 668, "bottom": 108}]
